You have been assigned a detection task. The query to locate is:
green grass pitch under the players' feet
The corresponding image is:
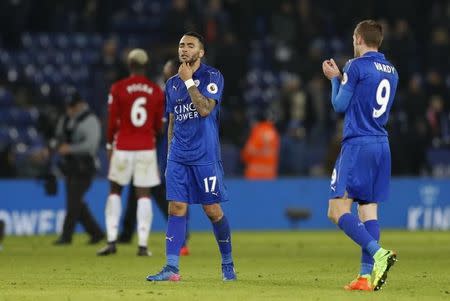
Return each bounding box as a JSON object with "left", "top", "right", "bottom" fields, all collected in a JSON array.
[{"left": 0, "top": 231, "right": 450, "bottom": 301}]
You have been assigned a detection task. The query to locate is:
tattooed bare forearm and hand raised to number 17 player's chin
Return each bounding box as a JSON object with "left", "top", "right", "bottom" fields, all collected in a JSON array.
[{"left": 178, "top": 62, "right": 216, "bottom": 117}]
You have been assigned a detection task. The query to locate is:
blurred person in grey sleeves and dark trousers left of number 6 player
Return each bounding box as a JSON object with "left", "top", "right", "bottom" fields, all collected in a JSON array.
[{"left": 50, "top": 90, "right": 105, "bottom": 245}]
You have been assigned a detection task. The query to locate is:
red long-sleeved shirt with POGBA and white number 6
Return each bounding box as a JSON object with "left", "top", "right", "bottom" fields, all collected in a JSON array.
[{"left": 107, "top": 75, "right": 164, "bottom": 150}]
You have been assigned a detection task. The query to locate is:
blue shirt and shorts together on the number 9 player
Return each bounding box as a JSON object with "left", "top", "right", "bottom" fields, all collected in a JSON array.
[{"left": 330, "top": 51, "right": 398, "bottom": 203}]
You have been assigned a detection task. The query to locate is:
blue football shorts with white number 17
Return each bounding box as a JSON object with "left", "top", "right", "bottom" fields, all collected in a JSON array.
[{"left": 166, "top": 160, "right": 228, "bottom": 205}]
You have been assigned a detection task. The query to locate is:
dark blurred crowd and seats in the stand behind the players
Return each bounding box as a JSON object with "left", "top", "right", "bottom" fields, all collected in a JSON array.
[{"left": 0, "top": 0, "right": 450, "bottom": 177}]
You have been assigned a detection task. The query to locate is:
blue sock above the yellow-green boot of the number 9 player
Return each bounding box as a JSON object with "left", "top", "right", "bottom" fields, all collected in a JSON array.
[{"left": 338, "top": 213, "right": 380, "bottom": 256}]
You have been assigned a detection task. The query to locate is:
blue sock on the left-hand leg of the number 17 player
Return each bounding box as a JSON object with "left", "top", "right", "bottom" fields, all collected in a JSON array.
[{"left": 166, "top": 215, "right": 186, "bottom": 268}]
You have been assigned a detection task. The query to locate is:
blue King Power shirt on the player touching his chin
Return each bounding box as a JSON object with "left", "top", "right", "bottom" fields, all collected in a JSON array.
[{"left": 165, "top": 64, "right": 223, "bottom": 165}]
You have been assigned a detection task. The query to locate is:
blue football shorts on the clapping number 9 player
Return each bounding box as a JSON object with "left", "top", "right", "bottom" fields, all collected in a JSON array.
[{"left": 330, "top": 137, "right": 391, "bottom": 203}]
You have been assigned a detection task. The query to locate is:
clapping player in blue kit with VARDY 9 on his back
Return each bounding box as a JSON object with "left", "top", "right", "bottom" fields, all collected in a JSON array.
[{"left": 322, "top": 20, "right": 398, "bottom": 291}]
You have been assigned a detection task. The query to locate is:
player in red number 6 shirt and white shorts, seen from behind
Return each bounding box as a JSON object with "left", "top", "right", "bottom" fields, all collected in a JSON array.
[{"left": 97, "top": 49, "right": 164, "bottom": 256}]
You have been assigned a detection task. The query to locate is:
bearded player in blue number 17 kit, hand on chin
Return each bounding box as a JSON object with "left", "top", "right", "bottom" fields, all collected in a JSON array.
[{"left": 147, "top": 32, "right": 236, "bottom": 281}]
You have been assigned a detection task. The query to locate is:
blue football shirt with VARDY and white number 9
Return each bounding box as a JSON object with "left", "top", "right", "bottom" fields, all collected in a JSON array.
[{"left": 340, "top": 51, "right": 398, "bottom": 141}]
